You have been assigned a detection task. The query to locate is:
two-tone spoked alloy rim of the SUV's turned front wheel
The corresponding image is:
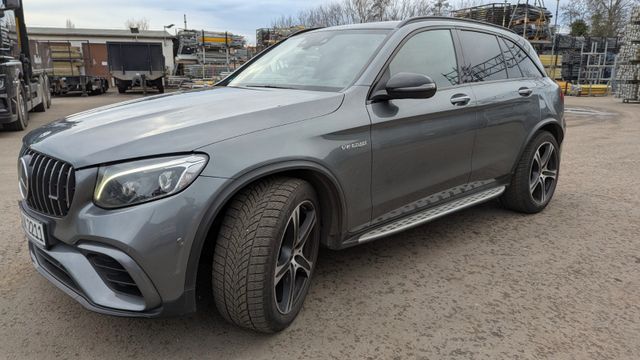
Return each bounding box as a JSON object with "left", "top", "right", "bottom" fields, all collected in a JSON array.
[{"left": 273, "top": 200, "right": 318, "bottom": 315}]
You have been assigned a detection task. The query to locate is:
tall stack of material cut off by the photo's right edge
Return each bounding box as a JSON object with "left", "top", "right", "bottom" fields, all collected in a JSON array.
[{"left": 616, "top": 7, "right": 640, "bottom": 102}]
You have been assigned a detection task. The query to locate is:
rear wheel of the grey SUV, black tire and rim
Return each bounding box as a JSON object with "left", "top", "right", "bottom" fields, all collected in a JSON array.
[{"left": 500, "top": 131, "right": 560, "bottom": 214}]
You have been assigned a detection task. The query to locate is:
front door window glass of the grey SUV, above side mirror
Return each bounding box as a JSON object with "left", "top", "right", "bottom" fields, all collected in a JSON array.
[{"left": 388, "top": 30, "right": 459, "bottom": 88}]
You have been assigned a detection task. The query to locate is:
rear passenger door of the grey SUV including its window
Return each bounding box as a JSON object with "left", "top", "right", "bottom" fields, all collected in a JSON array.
[{"left": 458, "top": 30, "right": 540, "bottom": 184}]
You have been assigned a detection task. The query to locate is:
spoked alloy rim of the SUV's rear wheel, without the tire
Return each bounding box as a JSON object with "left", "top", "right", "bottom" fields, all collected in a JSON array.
[{"left": 529, "top": 142, "right": 558, "bottom": 204}]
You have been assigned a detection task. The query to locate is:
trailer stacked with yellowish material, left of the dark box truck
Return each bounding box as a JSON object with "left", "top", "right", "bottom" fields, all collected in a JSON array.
[{"left": 46, "top": 42, "right": 109, "bottom": 96}]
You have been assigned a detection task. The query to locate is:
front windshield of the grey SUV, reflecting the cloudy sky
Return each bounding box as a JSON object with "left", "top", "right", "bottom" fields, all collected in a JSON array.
[{"left": 228, "top": 30, "right": 387, "bottom": 91}]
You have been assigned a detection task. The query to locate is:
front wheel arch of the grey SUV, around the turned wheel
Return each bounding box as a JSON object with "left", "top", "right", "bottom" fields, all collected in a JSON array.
[{"left": 184, "top": 160, "right": 346, "bottom": 309}]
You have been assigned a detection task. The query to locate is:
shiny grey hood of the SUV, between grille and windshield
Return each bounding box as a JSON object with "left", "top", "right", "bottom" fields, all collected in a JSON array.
[{"left": 24, "top": 87, "right": 344, "bottom": 168}]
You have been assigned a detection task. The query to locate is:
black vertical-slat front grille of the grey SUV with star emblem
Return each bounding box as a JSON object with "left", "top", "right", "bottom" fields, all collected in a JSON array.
[{"left": 24, "top": 149, "right": 76, "bottom": 217}]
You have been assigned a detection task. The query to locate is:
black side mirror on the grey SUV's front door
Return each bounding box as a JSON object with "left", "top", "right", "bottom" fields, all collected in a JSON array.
[{"left": 372, "top": 73, "right": 438, "bottom": 101}]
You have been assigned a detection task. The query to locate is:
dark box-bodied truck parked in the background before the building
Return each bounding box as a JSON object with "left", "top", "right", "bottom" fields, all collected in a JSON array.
[{"left": 107, "top": 42, "right": 165, "bottom": 94}]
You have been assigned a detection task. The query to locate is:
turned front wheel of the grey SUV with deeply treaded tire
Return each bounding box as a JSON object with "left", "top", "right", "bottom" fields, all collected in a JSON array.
[{"left": 212, "top": 178, "right": 320, "bottom": 333}]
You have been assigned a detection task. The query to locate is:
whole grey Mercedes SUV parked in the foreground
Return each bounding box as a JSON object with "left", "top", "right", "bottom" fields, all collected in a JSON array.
[{"left": 19, "top": 17, "right": 565, "bottom": 332}]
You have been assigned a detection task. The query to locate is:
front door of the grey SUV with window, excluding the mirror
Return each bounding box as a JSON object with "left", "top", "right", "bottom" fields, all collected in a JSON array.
[{"left": 367, "top": 29, "right": 478, "bottom": 224}]
